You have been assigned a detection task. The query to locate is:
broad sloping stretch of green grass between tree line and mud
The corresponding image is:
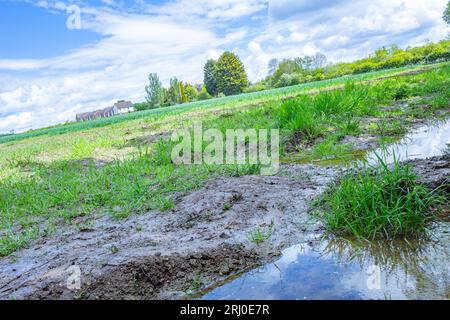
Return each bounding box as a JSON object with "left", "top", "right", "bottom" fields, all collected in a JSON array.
[{"left": 0, "top": 65, "right": 450, "bottom": 256}]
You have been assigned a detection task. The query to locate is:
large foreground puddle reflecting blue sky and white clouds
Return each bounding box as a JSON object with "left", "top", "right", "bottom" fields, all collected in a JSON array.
[{"left": 202, "top": 230, "right": 450, "bottom": 300}]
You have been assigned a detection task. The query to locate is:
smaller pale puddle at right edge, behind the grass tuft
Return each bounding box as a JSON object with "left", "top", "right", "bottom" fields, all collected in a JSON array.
[{"left": 366, "top": 119, "right": 450, "bottom": 164}]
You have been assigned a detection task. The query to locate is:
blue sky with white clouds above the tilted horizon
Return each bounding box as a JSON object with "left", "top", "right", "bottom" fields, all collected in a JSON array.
[{"left": 0, "top": 0, "right": 449, "bottom": 133}]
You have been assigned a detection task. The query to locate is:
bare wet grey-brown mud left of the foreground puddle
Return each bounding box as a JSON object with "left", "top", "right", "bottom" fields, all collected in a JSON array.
[{"left": 0, "top": 156, "right": 450, "bottom": 299}]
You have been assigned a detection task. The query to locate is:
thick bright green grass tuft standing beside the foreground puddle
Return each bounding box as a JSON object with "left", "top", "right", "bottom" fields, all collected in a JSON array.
[{"left": 318, "top": 157, "right": 443, "bottom": 239}]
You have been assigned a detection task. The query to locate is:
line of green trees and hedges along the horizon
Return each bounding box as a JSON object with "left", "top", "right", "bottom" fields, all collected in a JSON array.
[{"left": 134, "top": 1, "right": 450, "bottom": 110}]
